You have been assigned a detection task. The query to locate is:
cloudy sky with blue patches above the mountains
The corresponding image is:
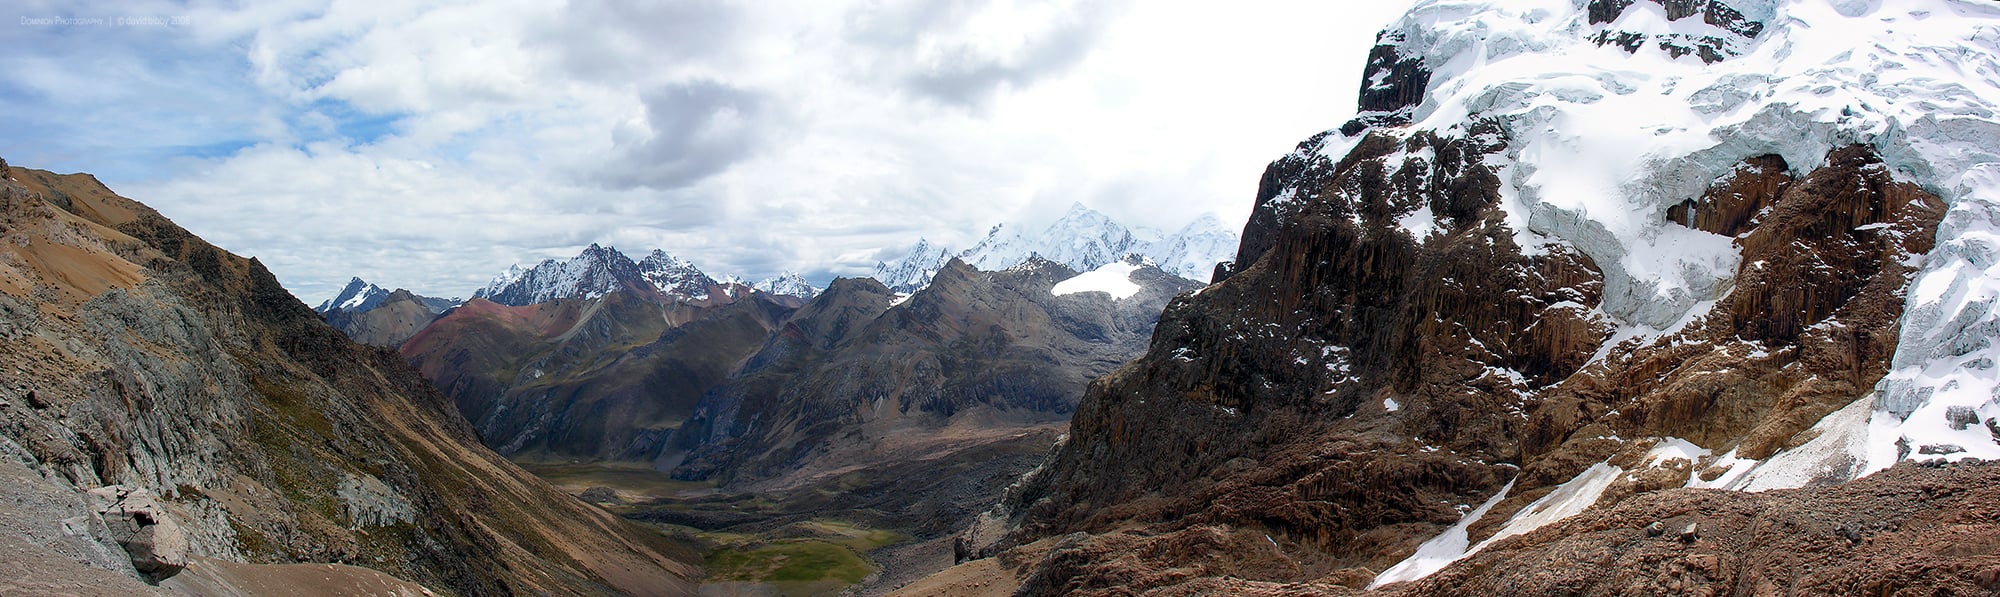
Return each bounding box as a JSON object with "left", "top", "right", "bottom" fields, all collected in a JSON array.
[{"left": 11, "top": 0, "right": 1410, "bottom": 303}]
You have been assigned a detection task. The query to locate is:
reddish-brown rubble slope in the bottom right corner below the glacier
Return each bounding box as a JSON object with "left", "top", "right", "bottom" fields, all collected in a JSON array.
[{"left": 1396, "top": 463, "right": 2000, "bottom": 595}]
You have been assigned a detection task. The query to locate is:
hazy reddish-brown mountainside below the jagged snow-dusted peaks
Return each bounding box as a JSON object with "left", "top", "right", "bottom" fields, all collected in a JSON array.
[{"left": 400, "top": 290, "right": 796, "bottom": 461}]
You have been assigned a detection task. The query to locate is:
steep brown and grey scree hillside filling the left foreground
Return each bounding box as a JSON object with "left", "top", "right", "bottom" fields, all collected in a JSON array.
[{"left": 0, "top": 168, "right": 698, "bottom": 595}]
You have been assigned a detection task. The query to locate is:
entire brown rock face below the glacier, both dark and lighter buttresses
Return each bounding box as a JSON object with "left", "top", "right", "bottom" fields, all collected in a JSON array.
[{"left": 988, "top": 128, "right": 1944, "bottom": 595}]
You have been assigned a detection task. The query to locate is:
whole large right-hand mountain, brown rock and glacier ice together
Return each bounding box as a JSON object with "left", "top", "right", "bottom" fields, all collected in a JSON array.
[{"left": 912, "top": 0, "right": 2000, "bottom": 595}]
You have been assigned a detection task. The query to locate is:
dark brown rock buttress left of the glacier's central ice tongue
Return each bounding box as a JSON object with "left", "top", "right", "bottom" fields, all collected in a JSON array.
[{"left": 1022, "top": 122, "right": 1608, "bottom": 587}]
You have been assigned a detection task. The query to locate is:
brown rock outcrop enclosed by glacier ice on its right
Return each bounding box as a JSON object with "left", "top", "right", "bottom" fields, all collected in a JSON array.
[{"left": 1522, "top": 146, "right": 1944, "bottom": 484}]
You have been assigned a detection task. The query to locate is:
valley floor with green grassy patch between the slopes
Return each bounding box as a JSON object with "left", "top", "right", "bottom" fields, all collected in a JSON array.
[{"left": 518, "top": 425, "right": 1068, "bottom": 597}]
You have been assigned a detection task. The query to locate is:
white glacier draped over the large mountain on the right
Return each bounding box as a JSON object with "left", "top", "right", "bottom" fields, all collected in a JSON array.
[{"left": 1360, "top": 0, "right": 2000, "bottom": 583}]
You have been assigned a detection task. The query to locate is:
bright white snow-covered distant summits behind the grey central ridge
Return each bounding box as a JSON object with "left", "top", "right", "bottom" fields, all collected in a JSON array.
[{"left": 874, "top": 202, "right": 1238, "bottom": 292}]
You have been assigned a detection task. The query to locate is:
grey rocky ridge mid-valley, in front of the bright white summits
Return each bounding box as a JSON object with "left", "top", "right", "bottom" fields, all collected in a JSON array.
[{"left": 660, "top": 258, "right": 1194, "bottom": 487}]
